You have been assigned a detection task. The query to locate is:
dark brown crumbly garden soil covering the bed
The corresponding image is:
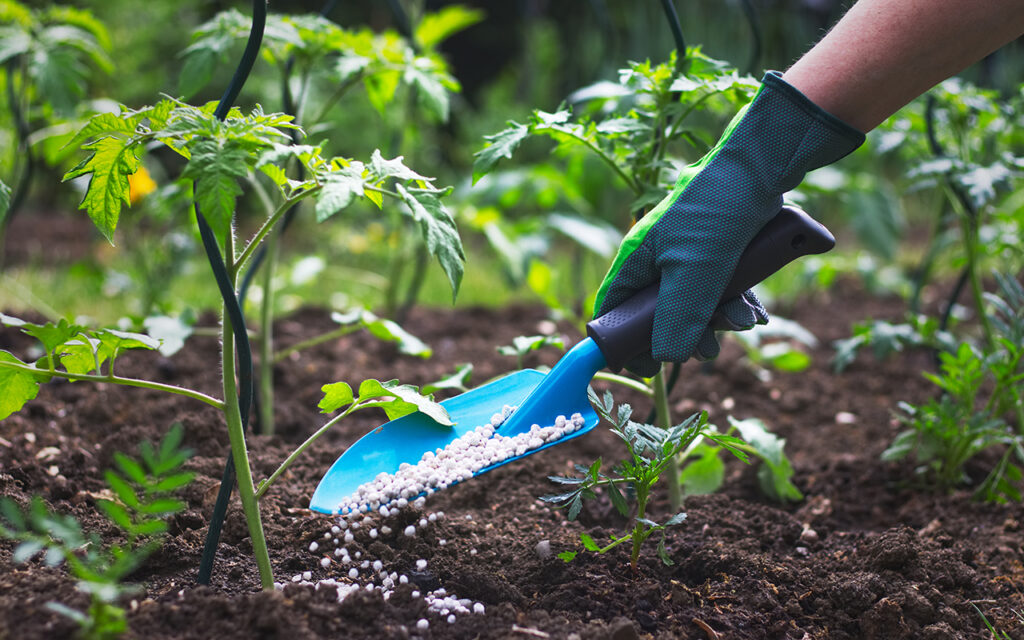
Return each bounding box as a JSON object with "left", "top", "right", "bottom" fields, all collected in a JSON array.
[{"left": 0, "top": 287, "right": 1024, "bottom": 640}]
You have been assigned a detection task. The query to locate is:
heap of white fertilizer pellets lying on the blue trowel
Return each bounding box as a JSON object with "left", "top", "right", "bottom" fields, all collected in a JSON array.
[{"left": 323, "top": 408, "right": 585, "bottom": 514}]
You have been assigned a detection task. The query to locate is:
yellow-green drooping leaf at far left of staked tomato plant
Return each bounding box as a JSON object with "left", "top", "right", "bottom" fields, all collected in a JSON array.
[{"left": 63, "top": 137, "right": 139, "bottom": 245}]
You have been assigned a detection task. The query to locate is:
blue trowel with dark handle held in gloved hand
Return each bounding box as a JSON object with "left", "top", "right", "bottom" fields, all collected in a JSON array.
[{"left": 309, "top": 207, "right": 836, "bottom": 513}]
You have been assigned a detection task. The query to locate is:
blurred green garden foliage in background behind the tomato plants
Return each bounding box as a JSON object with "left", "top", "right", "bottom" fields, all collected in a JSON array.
[{"left": 0, "top": 0, "right": 1024, "bottom": 323}]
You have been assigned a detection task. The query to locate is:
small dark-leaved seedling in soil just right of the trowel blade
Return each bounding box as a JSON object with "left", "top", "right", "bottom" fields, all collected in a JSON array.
[{"left": 541, "top": 389, "right": 748, "bottom": 571}]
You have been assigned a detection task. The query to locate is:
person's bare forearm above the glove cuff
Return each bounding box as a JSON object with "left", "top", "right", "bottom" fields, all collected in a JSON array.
[{"left": 782, "top": 0, "right": 1024, "bottom": 132}]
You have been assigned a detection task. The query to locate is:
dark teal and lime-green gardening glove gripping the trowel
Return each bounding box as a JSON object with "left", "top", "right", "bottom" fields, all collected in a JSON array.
[{"left": 594, "top": 72, "right": 864, "bottom": 377}]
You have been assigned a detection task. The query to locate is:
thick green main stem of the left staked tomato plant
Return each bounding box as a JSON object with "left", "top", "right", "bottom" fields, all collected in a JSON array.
[{"left": 220, "top": 233, "right": 273, "bottom": 591}]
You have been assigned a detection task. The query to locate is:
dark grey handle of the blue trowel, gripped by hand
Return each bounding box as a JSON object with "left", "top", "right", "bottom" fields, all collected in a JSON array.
[{"left": 587, "top": 206, "right": 836, "bottom": 371}]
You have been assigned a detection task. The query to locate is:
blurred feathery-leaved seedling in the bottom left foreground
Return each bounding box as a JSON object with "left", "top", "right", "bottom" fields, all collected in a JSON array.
[{"left": 0, "top": 424, "right": 195, "bottom": 640}]
